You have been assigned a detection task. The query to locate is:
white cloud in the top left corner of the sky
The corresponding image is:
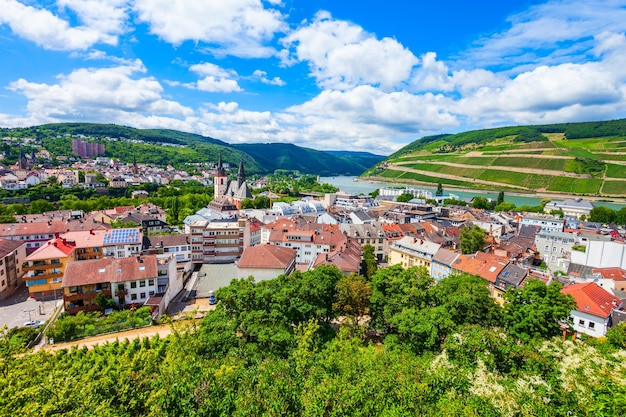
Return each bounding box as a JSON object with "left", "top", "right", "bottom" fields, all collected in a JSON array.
[{"left": 0, "top": 0, "right": 126, "bottom": 50}]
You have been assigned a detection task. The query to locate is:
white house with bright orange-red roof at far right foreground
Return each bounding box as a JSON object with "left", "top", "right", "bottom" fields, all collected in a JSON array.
[{"left": 561, "top": 282, "right": 622, "bottom": 337}]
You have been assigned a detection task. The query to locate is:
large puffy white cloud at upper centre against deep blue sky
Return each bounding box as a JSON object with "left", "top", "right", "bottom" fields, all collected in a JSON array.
[{"left": 282, "top": 12, "right": 418, "bottom": 90}]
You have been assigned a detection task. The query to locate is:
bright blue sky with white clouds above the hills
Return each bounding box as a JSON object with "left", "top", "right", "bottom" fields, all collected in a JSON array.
[{"left": 0, "top": 0, "right": 626, "bottom": 155}]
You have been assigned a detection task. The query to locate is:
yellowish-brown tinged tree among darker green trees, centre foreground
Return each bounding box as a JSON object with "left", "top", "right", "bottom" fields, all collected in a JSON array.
[{"left": 333, "top": 274, "right": 372, "bottom": 326}]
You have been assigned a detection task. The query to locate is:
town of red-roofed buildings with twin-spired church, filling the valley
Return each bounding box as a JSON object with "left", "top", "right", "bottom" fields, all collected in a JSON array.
[{"left": 0, "top": 150, "right": 626, "bottom": 337}]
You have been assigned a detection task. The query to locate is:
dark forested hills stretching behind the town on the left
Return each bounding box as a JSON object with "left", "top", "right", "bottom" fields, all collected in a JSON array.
[{"left": 0, "top": 123, "right": 383, "bottom": 175}]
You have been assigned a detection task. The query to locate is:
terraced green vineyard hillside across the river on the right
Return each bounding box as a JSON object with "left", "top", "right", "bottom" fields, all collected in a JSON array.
[{"left": 363, "top": 119, "right": 626, "bottom": 197}]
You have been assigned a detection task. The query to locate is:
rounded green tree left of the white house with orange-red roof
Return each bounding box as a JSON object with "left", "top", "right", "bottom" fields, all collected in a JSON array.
[{"left": 504, "top": 279, "right": 576, "bottom": 342}]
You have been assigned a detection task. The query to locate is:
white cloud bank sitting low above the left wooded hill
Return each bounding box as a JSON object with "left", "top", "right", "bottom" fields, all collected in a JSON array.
[{"left": 8, "top": 61, "right": 193, "bottom": 123}]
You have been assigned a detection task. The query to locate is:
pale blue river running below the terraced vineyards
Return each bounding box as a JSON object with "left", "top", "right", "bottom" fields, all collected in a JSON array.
[{"left": 320, "top": 176, "right": 626, "bottom": 210}]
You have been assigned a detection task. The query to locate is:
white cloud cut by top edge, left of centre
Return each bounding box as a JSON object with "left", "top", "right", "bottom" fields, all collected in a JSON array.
[{"left": 134, "top": 0, "right": 285, "bottom": 57}]
